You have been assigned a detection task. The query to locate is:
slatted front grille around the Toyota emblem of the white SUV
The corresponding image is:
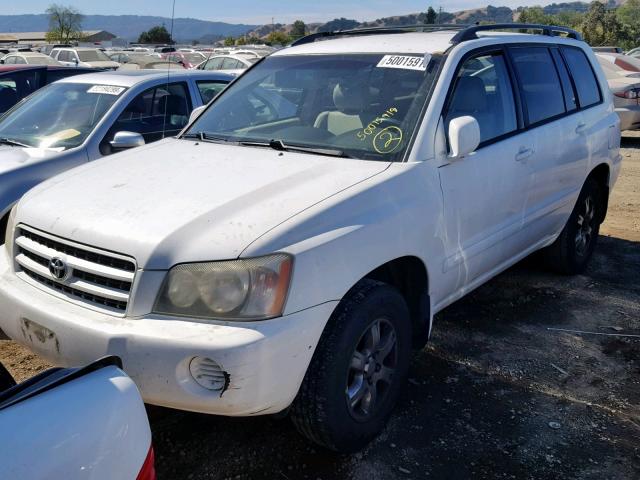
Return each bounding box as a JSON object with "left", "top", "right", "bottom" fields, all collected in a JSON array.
[{"left": 14, "top": 225, "right": 136, "bottom": 315}]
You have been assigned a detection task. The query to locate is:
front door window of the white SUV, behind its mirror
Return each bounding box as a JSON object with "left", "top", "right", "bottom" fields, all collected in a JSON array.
[{"left": 444, "top": 53, "right": 518, "bottom": 142}]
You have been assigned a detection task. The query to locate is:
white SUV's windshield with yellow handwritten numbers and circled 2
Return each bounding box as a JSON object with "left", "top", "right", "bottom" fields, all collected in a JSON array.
[{"left": 187, "top": 54, "right": 439, "bottom": 161}]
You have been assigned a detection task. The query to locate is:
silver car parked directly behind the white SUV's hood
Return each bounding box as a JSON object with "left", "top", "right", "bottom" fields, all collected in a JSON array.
[{"left": 0, "top": 70, "right": 235, "bottom": 236}]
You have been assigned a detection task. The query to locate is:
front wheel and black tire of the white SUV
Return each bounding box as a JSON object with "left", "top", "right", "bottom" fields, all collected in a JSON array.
[{"left": 291, "top": 279, "right": 411, "bottom": 453}]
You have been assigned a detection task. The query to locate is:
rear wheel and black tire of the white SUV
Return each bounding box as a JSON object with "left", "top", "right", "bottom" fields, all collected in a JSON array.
[{"left": 543, "top": 178, "right": 605, "bottom": 275}]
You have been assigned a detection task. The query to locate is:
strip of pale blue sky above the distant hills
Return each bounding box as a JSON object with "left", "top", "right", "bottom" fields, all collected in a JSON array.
[{"left": 7, "top": 0, "right": 551, "bottom": 24}]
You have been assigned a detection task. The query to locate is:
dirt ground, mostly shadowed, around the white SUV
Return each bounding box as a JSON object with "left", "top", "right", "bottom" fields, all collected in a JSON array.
[{"left": 0, "top": 135, "right": 640, "bottom": 480}]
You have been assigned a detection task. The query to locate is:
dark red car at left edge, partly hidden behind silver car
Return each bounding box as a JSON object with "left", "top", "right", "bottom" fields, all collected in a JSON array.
[{"left": 0, "top": 65, "right": 98, "bottom": 115}]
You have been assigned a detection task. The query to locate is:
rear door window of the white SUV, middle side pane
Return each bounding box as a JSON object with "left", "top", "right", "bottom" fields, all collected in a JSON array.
[{"left": 511, "top": 47, "right": 566, "bottom": 125}]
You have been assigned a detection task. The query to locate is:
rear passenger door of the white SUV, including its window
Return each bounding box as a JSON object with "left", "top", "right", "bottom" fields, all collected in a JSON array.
[{"left": 509, "top": 45, "right": 589, "bottom": 242}]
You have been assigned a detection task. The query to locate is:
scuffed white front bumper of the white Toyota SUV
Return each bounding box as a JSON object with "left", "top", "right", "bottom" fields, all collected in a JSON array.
[{"left": 0, "top": 252, "right": 336, "bottom": 416}]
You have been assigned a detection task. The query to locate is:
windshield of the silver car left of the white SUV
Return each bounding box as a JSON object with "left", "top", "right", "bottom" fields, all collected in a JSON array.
[{"left": 0, "top": 83, "right": 125, "bottom": 150}]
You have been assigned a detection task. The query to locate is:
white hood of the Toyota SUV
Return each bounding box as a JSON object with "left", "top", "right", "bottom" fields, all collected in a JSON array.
[{"left": 16, "top": 139, "right": 389, "bottom": 270}]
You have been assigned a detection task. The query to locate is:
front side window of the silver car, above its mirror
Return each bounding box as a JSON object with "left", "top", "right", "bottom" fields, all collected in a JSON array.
[{"left": 101, "top": 82, "right": 191, "bottom": 154}]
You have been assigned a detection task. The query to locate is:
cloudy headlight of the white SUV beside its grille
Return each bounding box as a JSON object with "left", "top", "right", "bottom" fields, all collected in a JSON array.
[{"left": 153, "top": 253, "right": 293, "bottom": 320}]
